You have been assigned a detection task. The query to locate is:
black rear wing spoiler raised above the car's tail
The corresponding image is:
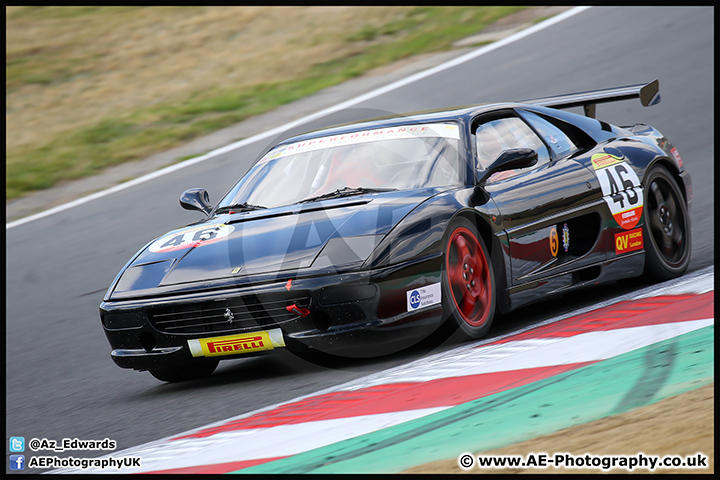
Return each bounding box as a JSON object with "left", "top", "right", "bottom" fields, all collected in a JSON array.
[{"left": 522, "top": 80, "right": 660, "bottom": 118}]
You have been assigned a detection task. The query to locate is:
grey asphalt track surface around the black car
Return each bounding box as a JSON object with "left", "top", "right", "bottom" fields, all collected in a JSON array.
[{"left": 6, "top": 7, "right": 714, "bottom": 472}]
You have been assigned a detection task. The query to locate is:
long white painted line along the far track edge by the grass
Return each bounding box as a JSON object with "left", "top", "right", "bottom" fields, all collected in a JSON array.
[{"left": 5, "top": 6, "right": 590, "bottom": 230}]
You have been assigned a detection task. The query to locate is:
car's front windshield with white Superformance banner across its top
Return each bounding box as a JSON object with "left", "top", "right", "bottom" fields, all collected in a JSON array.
[{"left": 218, "top": 123, "right": 462, "bottom": 209}]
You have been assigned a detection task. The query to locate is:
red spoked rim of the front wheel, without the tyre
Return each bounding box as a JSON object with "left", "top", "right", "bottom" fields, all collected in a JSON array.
[{"left": 445, "top": 227, "right": 492, "bottom": 327}]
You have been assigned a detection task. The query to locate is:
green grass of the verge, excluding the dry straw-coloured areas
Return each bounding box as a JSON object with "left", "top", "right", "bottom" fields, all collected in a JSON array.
[{"left": 5, "top": 7, "right": 525, "bottom": 199}]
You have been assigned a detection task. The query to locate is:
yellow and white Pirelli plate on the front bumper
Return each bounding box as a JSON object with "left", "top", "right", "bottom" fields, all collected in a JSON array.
[{"left": 188, "top": 328, "right": 285, "bottom": 357}]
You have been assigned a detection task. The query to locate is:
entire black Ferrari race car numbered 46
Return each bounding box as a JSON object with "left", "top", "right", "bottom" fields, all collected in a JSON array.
[{"left": 100, "top": 80, "right": 692, "bottom": 382}]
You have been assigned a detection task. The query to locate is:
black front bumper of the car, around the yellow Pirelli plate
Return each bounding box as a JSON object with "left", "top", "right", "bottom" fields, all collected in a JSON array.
[{"left": 100, "top": 254, "right": 443, "bottom": 370}]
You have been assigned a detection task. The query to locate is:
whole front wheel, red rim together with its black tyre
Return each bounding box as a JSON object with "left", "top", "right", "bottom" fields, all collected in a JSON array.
[{"left": 442, "top": 218, "right": 495, "bottom": 339}]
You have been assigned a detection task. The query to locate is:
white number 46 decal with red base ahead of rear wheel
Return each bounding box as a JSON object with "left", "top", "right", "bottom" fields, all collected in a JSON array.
[{"left": 590, "top": 153, "right": 643, "bottom": 230}]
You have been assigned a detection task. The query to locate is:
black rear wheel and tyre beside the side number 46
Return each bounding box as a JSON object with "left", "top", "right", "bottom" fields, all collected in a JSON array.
[{"left": 643, "top": 166, "right": 690, "bottom": 281}]
